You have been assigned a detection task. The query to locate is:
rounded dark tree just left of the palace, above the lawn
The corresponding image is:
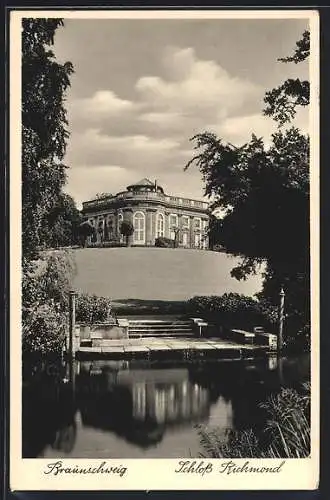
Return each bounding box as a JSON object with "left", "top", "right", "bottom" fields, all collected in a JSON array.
[{"left": 40, "top": 193, "right": 82, "bottom": 248}]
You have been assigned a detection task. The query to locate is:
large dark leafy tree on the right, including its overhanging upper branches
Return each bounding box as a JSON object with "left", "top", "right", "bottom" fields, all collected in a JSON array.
[{"left": 185, "top": 34, "right": 309, "bottom": 344}]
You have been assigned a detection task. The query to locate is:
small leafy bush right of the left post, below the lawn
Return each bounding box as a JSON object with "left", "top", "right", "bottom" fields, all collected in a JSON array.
[{"left": 76, "top": 294, "right": 112, "bottom": 324}]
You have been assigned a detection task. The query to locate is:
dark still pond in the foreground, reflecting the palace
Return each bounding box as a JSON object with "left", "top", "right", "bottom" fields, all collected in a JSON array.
[{"left": 22, "top": 356, "right": 310, "bottom": 458}]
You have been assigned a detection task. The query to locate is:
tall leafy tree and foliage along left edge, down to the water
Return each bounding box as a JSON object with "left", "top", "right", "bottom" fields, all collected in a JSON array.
[{"left": 22, "top": 18, "right": 78, "bottom": 354}]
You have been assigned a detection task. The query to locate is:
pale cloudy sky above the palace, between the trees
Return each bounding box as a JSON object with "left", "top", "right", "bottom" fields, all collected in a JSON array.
[{"left": 54, "top": 19, "right": 308, "bottom": 207}]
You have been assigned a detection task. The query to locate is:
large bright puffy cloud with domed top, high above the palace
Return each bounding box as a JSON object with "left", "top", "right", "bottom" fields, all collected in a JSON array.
[{"left": 135, "top": 48, "right": 260, "bottom": 119}]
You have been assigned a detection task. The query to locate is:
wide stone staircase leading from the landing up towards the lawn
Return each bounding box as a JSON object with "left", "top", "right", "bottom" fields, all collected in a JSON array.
[{"left": 128, "top": 318, "right": 194, "bottom": 338}]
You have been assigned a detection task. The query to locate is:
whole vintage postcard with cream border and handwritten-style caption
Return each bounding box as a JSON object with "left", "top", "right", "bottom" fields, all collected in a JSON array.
[{"left": 9, "top": 9, "right": 319, "bottom": 491}]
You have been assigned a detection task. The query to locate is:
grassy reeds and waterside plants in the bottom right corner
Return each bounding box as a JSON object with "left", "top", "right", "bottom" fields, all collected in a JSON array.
[{"left": 198, "top": 385, "right": 311, "bottom": 458}]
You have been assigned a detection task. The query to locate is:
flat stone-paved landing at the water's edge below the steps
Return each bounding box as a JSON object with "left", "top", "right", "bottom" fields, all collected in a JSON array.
[{"left": 76, "top": 337, "right": 270, "bottom": 360}]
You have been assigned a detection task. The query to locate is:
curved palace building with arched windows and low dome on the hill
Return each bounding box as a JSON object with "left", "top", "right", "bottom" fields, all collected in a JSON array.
[{"left": 82, "top": 179, "right": 209, "bottom": 249}]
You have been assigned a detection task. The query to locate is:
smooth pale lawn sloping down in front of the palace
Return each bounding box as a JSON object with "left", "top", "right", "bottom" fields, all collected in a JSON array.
[{"left": 74, "top": 248, "right": 261, "bottom": 304}]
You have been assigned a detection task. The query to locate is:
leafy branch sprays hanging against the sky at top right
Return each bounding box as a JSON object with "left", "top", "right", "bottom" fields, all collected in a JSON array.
[{"left": 264, "top": 31, "right": 310, "bottom": 125}]
